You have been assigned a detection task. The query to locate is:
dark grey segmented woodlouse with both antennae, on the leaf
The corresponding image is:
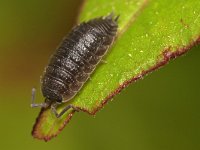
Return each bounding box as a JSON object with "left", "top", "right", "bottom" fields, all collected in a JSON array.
[{"left": 31, "top": 13, "right": 119, "bottom": 117}]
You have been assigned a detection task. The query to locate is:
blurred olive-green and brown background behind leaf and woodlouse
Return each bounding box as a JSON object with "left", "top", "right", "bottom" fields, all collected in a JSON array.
[{"left": 0, "top": 0, "right": 200, "bottom": 150}]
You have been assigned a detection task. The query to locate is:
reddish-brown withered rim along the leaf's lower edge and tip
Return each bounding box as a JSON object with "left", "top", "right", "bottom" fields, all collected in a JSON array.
[{"left": 32, "top": 36, "right": 200, "bottom": 141}]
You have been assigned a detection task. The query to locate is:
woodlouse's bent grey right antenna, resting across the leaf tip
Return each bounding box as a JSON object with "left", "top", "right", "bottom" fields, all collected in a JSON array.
[{"left": 51, "top": 103, "right": 79, "bottom": 118}]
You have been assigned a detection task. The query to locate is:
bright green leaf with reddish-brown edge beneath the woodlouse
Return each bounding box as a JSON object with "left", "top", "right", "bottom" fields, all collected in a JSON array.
[{"left": 32, "top": 0, "right": 200, "bottom": 141}]
